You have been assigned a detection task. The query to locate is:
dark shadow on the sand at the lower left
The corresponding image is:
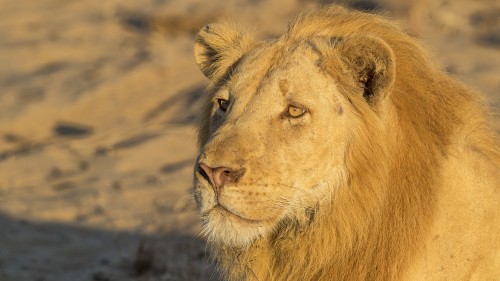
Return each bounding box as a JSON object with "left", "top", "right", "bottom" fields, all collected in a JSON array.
[{"left": 0, "top": 214, "right": 219, "bottom": 281}]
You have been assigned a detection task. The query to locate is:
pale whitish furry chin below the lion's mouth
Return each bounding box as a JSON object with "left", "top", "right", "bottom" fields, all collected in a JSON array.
[{"left": 203, "top": 205, "right": 272, "bottom": 247}]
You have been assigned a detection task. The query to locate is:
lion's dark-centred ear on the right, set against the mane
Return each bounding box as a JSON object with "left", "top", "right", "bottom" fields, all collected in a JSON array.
[{"left": 334, "top": 36, "right": 395, "bottom": 106}]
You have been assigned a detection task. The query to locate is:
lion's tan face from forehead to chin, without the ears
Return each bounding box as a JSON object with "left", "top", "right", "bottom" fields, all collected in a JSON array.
[{"left": 195, "top": 43, "right": 349, "bottom": 246}]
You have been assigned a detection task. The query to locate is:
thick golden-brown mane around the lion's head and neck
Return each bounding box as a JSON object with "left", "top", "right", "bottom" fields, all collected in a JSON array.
[{"left": 193, "top": 6, "right": 500, "bottom": 280}]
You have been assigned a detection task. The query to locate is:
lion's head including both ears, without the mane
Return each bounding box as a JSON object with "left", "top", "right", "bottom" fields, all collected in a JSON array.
[{"left": 191, "top": 13, "right": 394, "bottom": 246}]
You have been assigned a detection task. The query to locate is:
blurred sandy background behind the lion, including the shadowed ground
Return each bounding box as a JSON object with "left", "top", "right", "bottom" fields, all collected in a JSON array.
[{"left": 0, "top": 0, "right": 500, "bottom": 281}]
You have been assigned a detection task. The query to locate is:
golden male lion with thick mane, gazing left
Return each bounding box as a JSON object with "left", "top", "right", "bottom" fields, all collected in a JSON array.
[{"left": 193, "top": 6, "right": 500, "bottom": 281}]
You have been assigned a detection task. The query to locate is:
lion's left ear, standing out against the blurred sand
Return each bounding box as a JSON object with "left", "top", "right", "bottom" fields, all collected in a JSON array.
[{"left": 194, "top": 22, "right": 253, "bottom": 81}]
